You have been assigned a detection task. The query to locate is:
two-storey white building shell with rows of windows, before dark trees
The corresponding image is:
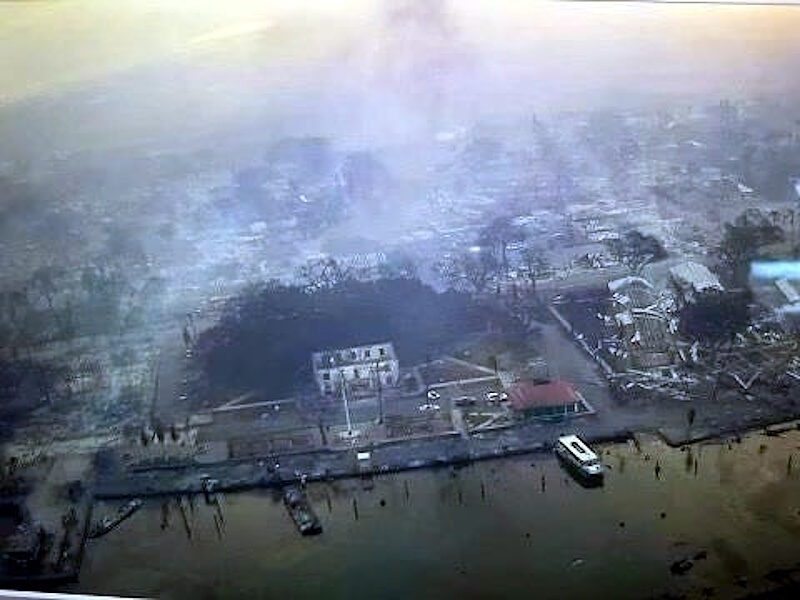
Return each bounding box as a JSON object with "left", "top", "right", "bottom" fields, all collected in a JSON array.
[{"left": 311, "top": 342, "right": 400, "bottom": 394}]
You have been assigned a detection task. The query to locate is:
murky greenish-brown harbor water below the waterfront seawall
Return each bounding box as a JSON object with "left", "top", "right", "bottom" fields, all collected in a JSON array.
[{"left": 73, "top": 431, "right": 800, "bottom": 599}]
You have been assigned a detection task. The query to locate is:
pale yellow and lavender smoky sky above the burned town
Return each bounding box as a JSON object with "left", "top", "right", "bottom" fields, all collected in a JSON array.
[{"left": 0, "top": 0, "right": 800, "bottom": 155}]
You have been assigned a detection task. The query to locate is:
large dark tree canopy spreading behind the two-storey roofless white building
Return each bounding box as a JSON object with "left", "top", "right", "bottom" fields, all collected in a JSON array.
[{"left": 197, "top": 278, "right": 515, "bottom": 397}]
